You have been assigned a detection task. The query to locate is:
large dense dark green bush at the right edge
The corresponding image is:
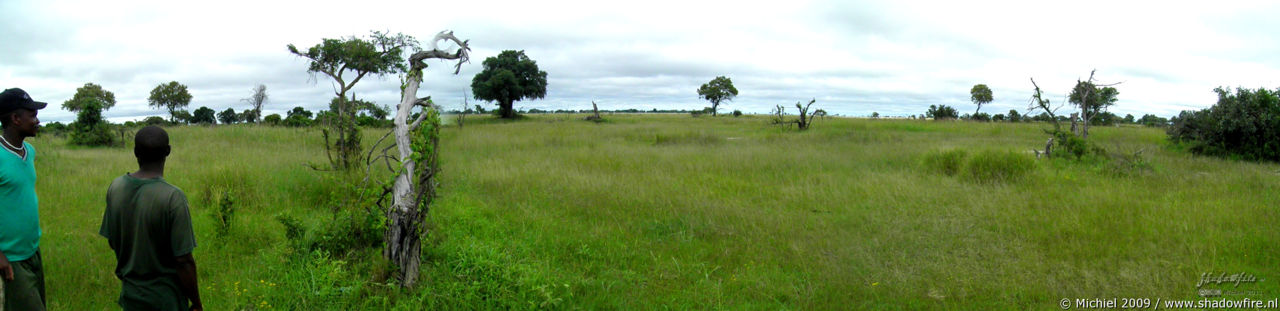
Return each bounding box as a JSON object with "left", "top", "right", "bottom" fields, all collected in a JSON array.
[{"left": 1172, "top": 87, "right": 1280, "bottom": 161}]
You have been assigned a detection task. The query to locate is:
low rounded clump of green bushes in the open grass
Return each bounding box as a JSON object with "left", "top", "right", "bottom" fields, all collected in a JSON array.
[{"left": 922, "top": 150, "right": 1036, "bottom": 183}]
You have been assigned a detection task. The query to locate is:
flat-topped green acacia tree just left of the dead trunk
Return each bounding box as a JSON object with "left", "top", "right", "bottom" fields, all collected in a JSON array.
[{"left": 288, "top": 31, "right": 419, "bottom": 169}]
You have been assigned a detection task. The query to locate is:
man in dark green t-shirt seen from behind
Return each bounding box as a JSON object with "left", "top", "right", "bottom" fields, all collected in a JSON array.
[{"left": 99, "top": 127, "right": 204, "bottom": 311}]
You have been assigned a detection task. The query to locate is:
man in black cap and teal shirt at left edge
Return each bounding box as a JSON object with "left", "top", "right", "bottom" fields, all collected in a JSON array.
[{"left": 0, "top": 88, "right": 47, "bottom": 311}]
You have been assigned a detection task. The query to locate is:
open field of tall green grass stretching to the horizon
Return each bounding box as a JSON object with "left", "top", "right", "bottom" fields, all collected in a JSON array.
[{"left": 31, "top": 115, "right": 1280, "bottom": 310}]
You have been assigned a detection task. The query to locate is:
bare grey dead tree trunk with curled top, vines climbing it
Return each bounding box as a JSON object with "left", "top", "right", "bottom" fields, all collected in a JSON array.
[{"left": 383, "top": 31, "right": 470, "bottom": 287}]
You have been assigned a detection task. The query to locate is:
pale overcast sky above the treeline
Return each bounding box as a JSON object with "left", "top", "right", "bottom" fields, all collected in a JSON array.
[{"left": 0, "top": 0, "right": 1280, "bottom": 123}]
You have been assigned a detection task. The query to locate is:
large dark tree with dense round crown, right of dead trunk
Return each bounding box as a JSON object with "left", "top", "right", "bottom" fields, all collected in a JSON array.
[{"left": 471, "top": 50, "right": 547, "bottom": 119}]
